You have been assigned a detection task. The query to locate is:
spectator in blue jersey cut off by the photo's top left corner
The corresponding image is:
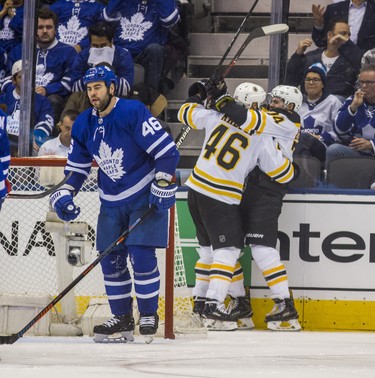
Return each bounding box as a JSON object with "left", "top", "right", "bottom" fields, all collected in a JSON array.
[{"left": 0, "top": 0, "right": 23, "bottom": 53}]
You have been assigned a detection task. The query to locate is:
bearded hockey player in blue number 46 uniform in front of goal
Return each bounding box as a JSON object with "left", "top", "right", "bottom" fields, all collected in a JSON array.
[{"left": 50, "top": 66, "right": 179, "bottom": 342}]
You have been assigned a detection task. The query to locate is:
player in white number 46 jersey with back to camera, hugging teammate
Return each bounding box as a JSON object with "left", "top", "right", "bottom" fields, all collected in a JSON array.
[{"left": 178, "top": 81, "right": 294, "bottom": 329}]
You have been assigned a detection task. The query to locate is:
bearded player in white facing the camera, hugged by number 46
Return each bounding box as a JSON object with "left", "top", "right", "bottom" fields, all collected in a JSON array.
[{"left": 221, "top": 85, "right": 302, "bottom": 331}]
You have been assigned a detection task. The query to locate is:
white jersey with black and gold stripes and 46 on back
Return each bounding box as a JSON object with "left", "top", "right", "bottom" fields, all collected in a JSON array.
[{"left": 178, "top": 103, "right": 294, "bottom": 205}]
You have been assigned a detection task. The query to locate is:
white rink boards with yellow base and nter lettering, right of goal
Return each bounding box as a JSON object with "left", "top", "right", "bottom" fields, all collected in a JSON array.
[{"left": 177, "top": 191, "right": 375, "bottom": 330}]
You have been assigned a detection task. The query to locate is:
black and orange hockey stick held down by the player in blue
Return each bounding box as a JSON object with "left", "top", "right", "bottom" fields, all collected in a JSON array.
[{"left": 0, "top": 207, "right": 154, "bottom": 344}]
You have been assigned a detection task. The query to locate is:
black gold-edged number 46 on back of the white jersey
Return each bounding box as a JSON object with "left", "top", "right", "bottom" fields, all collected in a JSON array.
[{"left": 204, "top": 125, "right": 249, "bottom": 170}]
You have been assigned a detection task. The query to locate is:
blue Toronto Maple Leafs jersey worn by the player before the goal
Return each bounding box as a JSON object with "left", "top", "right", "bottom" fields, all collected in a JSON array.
[{"left": 65, "top": 99, "right": 179, "bottom": 207}]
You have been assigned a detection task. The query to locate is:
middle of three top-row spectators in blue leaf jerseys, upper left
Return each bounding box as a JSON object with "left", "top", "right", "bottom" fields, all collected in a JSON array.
[{"left": 49, "top": 0, "right": 104, "bottom": 52}]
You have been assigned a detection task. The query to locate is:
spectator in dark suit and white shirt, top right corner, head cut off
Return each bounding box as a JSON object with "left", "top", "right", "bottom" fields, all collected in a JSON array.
[{"left": 312, "top": 0, "right": 375, "bottom": 52}]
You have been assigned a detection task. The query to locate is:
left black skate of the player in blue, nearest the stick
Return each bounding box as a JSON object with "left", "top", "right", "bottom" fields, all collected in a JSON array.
[{"left": 94, "top": 313, "right": 134, "bottom": 343}]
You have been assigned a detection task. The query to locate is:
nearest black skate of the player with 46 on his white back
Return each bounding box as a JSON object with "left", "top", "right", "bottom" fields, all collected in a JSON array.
[{"left": 202, "top": 298, "right": 237, "bottom": 331}]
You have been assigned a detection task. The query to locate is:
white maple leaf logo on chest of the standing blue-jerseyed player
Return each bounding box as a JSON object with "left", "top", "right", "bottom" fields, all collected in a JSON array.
[{"left": 94, "top": 140, "right": 126, "bottom": 181}]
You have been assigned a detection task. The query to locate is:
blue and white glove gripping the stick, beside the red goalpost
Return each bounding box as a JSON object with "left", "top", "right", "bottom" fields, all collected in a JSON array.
[{"left": 150, "top": 173, "right": 177, "bottom": 213}]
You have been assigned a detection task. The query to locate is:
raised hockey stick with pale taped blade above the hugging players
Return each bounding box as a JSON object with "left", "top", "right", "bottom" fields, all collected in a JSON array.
[{"left": 175, "top": 24, "right": 289, "bottom": 147}]
